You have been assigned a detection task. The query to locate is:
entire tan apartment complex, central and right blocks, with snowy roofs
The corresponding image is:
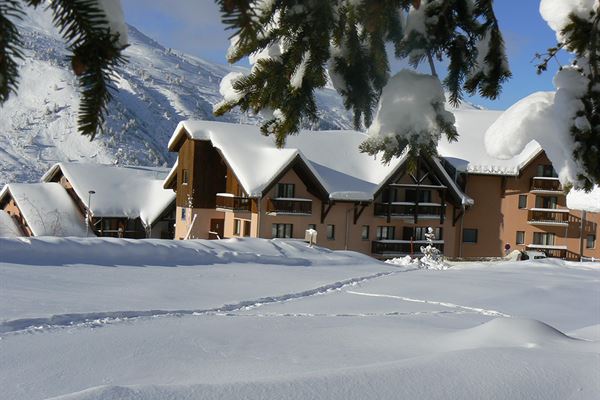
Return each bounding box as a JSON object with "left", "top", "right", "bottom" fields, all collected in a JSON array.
[{"left": 165, "top": 119, "right": 600, "bottom": 259}]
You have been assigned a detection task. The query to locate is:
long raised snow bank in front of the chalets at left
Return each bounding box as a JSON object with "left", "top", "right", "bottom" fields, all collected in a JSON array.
[{"left": 0, "top": 236, "right": 379, "bottom": 266}]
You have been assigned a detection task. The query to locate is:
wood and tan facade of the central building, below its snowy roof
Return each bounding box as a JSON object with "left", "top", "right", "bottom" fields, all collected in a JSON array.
[{"left": 165, "top": 124, "right": 472, "bottom": 258}]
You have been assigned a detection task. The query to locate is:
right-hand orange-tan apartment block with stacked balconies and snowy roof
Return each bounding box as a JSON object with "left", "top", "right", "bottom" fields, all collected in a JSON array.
[{"left": 438, "top": 110, "right": 600, "bottom": 260}]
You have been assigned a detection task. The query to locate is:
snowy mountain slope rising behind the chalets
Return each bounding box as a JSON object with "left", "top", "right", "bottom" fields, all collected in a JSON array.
[{"left": 0, "top": 10, "right": 352, "bottom": 185}]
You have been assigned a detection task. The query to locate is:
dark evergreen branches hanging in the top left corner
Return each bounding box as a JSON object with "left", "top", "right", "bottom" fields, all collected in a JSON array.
[{"left": 0, "top": 0, "right": 125, "bottom": 139}]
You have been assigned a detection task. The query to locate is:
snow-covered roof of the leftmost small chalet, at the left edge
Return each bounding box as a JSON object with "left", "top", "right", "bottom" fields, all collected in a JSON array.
[{"left": 0, "top": 183, "right": 86, "bottom": 236}]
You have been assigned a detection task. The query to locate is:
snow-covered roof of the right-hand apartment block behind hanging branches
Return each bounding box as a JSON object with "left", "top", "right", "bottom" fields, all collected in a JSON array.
[{"left": 438, "top": 108, "right": 542, "bottom": 175}]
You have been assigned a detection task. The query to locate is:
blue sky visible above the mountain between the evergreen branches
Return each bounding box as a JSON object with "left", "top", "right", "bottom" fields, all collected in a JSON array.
[{"left": 122, "top": 0, "right": 568, "bottom": 109}]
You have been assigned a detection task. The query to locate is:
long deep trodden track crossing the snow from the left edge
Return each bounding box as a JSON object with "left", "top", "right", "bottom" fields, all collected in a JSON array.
[{"left": 0, "top": 270, "right": 398, "bottom": 339}]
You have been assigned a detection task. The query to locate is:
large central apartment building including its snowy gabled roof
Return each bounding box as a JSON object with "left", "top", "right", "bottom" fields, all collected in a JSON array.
[{"left": 165, "top": 121, "right": 472, "bottom": 257}]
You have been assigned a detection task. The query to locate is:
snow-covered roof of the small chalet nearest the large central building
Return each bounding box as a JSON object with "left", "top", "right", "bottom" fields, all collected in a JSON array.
[{"left": 42, "top": 163, "right": 175, "bottom": 226}]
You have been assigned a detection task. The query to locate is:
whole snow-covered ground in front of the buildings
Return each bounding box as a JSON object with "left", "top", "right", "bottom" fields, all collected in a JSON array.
[{"left": 0, "top": 238, "right": 600, "bottom": 400}]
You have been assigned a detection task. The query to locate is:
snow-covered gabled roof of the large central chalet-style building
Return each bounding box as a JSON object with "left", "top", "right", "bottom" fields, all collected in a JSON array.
[{"left": 169, "top": 120, "right": 404, "bottom": 201}]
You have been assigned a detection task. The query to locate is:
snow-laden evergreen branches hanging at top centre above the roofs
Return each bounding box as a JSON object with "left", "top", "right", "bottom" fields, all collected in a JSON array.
[{"left": 215, "top": 0, "right": 510, "bottom": 161}]
